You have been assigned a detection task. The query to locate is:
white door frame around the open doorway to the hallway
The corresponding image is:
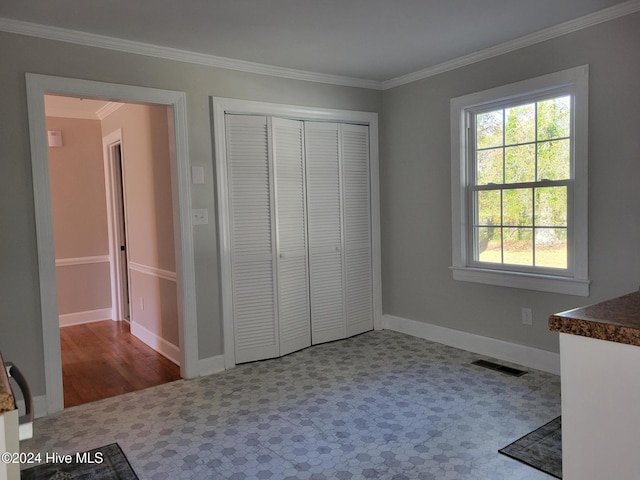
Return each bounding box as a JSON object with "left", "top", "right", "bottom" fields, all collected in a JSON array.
[{"left": 26, "top": 73, "right": 198, "bottom": 413}]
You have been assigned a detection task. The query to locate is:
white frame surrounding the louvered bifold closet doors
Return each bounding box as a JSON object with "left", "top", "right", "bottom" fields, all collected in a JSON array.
[{"left": 211, "top": 97, "right": 382, "bottom": 369}]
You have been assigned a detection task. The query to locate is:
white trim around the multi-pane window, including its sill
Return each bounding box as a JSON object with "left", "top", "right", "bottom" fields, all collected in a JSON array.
[{"left": 451, "top": 65, "right": 589, "bottom": 297}]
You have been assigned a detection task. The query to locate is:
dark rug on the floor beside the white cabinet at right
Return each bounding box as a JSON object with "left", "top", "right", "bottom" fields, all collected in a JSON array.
[{"left": 498, "top": 417, "right": 562, "bottom": 478}]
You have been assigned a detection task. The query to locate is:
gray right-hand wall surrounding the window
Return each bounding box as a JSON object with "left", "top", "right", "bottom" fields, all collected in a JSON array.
[{"left": 380, "top": 14, "right": 640, "bottom": 351}]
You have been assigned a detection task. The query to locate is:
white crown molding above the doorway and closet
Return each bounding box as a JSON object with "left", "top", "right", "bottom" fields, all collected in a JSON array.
[{"left": 0, "top": 17, "right": 382, "bottom": 90}]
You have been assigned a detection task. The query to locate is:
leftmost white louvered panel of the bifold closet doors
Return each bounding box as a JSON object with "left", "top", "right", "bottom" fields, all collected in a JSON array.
[{"left": 225, "top": 115, "right": 279, "bottom": 363}]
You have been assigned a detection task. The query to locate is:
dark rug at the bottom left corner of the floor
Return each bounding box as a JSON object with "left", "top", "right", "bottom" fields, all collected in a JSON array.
[{"left": 20, "top": 443, "right": 138, "bottom": 480}]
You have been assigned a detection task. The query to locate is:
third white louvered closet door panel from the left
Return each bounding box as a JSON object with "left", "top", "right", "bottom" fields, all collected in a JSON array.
[{"left": 305, "top": 122, "right": 347, "bottom": 344}]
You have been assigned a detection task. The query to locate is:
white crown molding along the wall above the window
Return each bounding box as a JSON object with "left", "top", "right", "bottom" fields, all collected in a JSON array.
[{"left": 382, "top": 0, "right": 640, "bottom": 90}]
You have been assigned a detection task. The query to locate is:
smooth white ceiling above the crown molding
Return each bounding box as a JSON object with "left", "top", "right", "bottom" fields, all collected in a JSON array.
[{"left": 0, "top": 0, "right": 638, "bottom": 81}]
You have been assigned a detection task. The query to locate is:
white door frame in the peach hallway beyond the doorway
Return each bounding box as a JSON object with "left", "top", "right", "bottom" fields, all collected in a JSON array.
[{"left": 102, "top": 128, "right": 131, "bottom": 321}]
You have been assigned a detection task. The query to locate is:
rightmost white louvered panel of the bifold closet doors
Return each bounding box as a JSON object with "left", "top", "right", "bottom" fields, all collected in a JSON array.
[{"left": 340, "top": 124, "right": 373, "bottom": 336}]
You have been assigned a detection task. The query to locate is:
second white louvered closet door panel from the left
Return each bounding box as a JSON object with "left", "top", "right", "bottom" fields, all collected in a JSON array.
[{"left": 271, "top": 118, "right": 311, "bottom": 355}]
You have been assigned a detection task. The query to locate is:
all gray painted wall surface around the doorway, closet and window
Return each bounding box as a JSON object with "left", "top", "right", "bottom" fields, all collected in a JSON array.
[{"left": 0, "top": 14, "right": 640, "bottom": 402}]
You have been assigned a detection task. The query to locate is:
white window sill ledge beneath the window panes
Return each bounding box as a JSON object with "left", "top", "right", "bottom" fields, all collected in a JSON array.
[{"left": 450, "top": 267, "right": 590, "bottom": 297}]
